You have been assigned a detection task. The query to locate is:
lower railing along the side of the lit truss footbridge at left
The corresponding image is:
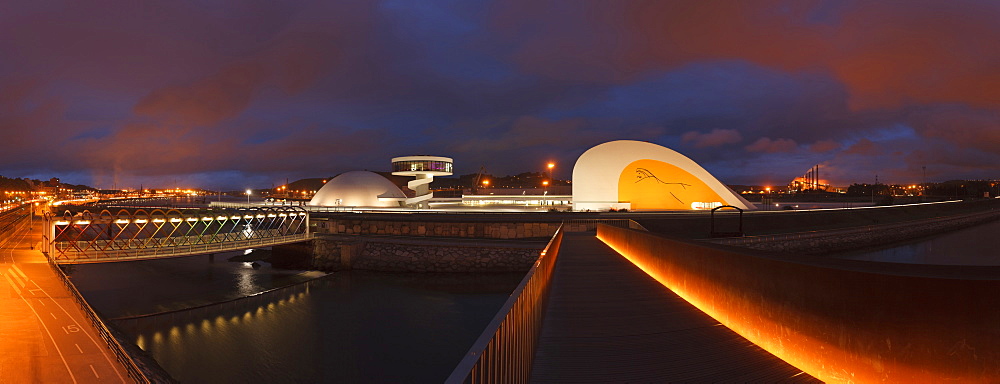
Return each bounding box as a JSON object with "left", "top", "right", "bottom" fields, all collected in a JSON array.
[{"left": 55, "top": 233, "right": 312, "bottom": 264}]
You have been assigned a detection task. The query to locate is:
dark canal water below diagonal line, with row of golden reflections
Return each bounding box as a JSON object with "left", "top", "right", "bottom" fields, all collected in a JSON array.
[{"left": 95, "top": 271, "right": 523, "bottom": 383}]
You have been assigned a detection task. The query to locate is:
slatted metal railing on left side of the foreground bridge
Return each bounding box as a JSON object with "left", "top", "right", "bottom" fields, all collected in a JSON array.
[{"left": 445, "top": 226, "right": 564, "bottom": 384}]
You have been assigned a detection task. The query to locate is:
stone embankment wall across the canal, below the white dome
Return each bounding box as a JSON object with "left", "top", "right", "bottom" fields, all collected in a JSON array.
[{"left": 311, "top": 236, "right": 545, "bottom": 272}]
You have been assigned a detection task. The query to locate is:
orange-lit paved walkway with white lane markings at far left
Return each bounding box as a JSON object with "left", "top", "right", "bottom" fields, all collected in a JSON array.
[{"left": 0, "top": 217, "right": 132, "bottom": 384}]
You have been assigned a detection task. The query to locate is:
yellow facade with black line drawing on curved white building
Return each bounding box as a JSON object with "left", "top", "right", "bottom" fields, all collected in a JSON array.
[{"left": 618, "top": 159, "right": 723, "bottom": 210}]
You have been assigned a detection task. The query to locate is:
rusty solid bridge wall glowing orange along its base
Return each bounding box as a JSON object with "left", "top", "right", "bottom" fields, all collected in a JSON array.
[{"left": 598, "top": 225, "right": 1000, "bottom": 382}]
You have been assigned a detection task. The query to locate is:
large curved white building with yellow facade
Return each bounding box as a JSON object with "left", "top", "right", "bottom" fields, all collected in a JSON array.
[{"left": 573, "top": 140, "right": 753, "bottom": 211}]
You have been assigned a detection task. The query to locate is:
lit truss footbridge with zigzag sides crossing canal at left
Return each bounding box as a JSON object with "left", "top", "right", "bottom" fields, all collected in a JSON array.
[{"left": 42, "top": 207, "right": 310, "bottom": 264}]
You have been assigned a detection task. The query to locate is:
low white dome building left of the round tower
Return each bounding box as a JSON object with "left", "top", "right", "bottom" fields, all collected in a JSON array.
[{"left": 309, "top": 171, "right": 406, "bottom": 207}]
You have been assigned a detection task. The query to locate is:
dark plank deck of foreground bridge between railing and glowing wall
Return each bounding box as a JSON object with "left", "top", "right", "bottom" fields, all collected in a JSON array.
[{"left": 531, "top": 233, "right": 819, "bottom": 383}]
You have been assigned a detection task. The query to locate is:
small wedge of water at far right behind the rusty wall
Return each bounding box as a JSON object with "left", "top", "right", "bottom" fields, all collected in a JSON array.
[{"left": 834, "top": 221, "right": 1000, "bottom": 265}]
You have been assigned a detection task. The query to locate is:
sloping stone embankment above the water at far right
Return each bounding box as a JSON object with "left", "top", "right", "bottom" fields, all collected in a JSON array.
[{"left": 705, "top": 210, "right": 1000, "bottom": 255}]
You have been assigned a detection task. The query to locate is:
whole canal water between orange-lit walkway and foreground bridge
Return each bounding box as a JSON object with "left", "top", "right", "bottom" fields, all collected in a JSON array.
[{"left": 71, "top": 255, "right": 524, "bottom": 383}]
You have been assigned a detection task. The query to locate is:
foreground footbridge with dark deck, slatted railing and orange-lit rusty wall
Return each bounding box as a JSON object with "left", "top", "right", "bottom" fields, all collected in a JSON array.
[{"left": 446, "top": 223, "right": 1000, "bottom": 384}]
